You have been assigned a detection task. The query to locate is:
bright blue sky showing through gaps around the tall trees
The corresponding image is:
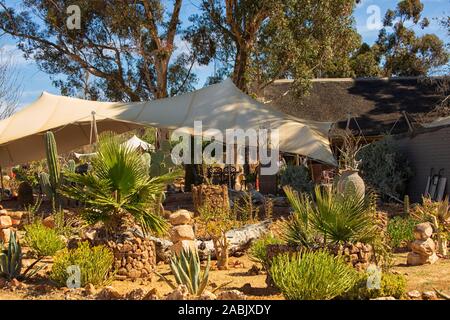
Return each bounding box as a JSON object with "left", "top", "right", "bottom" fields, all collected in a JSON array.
[{"left": 0, "top": 0, "right": 450, "bottom": 106}]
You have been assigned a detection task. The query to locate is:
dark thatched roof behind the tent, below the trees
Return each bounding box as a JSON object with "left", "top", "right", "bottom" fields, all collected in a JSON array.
[{"left": 260, "top": 77, "right": 440, "bottom": 135}]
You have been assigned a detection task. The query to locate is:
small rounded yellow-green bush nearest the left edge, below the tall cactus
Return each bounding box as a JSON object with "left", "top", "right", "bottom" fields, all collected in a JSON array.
[{"left": 25, "top": 221, "right": 65, "bottom": 258}]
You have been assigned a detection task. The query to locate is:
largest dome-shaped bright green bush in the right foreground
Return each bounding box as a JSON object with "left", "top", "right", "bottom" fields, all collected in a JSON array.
[{"left": 270, "top": 251, "right": 358, "bottom": 300}]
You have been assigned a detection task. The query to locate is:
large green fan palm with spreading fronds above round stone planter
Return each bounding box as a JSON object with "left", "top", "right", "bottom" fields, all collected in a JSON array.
[{"left": 62, "top": 133, "right": 179, "bottom": 234}]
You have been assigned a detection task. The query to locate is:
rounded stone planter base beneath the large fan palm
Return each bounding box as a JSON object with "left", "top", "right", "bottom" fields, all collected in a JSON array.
[{"left": 107, "top": 237, "right": 156, "bottom": 280}]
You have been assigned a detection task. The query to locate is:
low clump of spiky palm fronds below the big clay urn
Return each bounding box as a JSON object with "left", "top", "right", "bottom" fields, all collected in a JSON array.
[{"left": 285, "top": 187, "right": 378, "bottom": 246}]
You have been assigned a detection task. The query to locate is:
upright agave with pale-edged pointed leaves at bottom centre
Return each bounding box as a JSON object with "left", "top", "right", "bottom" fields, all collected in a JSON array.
[{"left": 164, "top": 250, "right": 211, "bottom": 296}]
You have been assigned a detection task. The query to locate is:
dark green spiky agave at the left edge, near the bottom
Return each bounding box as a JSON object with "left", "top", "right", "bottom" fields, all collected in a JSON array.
[{"left": 0, "top": 232, "right": 22, "bottom": 280}]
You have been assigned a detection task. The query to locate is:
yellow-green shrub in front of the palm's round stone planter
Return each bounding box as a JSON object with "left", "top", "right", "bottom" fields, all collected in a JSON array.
[{"left": 50, "top": 242, "right": 114, "bottom": 287}]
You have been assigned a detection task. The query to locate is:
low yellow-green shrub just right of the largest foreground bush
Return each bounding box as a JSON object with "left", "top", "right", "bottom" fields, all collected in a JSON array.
[{"left": 341, "top": 273, "right": 406, "bottom": 300}]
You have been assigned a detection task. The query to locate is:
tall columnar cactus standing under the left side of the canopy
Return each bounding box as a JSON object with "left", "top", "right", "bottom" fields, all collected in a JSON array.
[{"left": 44, "top": 131, "right": 61, "bottom": 209}]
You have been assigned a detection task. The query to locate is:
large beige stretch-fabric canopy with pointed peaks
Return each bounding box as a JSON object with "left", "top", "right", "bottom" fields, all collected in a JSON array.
[{"left": 0, "top": 79, "right": 336, "bottom": 166}]
